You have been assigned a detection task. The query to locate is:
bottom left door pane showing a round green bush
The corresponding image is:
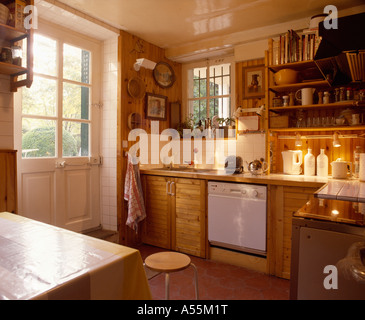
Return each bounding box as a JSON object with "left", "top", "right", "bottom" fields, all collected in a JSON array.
[{"left": 22, "top": 118, "right": 56, "bottom": 158}]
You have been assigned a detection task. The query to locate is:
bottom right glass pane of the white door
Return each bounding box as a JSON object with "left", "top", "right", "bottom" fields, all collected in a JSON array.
[{"left": 62, "top": 121, "right": 90, "bottom": 157}]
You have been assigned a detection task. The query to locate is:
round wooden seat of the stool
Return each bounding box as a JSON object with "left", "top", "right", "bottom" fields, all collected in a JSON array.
[{"left": 145, "top": 252, "right": 191, "bottom": 272}]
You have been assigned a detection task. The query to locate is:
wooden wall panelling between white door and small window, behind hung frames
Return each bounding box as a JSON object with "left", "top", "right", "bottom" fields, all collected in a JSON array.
[{"left": 117, "top": 31, "right": 182, "bottom": 245}]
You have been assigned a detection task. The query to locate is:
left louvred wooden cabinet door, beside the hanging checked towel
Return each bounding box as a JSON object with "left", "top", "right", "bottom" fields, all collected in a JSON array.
[{"left": 142, "top": 175, "right": 171, "bottom": 249}]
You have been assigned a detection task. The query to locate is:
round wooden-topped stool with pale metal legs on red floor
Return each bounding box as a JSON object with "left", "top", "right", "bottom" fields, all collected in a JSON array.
[{"left": 145, "top": 252, "right": 199, "bottom": 300}]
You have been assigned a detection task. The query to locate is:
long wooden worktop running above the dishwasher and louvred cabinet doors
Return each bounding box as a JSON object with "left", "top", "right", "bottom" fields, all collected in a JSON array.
[{"left": 140, "top": 167, "right": 328, "bottom": 188}]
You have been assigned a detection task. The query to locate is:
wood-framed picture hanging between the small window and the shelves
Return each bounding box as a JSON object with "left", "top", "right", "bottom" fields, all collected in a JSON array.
[{"left": 243, "top": 65, "right": 265, "bottom": 99}]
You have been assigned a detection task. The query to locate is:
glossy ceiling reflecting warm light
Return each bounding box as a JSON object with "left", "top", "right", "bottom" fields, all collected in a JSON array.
[{"left": 38, "top": 0, "right": 364, "bottom": 61}]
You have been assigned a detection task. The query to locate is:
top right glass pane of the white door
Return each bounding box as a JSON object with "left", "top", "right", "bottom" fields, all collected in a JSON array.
[{"left": 63, "top": 44, "right": 91, "bottom": 84}]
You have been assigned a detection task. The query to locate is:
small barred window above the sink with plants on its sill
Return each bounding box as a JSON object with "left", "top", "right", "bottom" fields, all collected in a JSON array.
[{"left": 186, "top": 59, "right": 233, "bottom": 124}]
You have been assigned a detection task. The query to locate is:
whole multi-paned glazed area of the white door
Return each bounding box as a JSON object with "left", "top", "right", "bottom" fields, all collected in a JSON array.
[{"left": 22, "top": 34, "right": 92, "bottom": 158}]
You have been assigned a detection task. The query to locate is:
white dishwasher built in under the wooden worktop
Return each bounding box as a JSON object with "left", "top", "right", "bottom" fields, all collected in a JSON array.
[{"left": 208, "top": 181, "right": 267, "bottom": 255}]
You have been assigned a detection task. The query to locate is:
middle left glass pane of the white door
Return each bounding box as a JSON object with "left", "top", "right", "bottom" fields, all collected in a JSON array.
[{"left": 22, "top": 76, "right": 57, "bottom": 116}]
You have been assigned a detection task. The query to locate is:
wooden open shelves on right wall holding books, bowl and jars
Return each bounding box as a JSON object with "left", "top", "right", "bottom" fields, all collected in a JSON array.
[{"left": 265, "top": 39, "right": 365, "bottom": 178}]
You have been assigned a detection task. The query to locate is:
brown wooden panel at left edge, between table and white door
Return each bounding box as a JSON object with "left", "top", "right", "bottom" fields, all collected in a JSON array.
[{"left": 0, "top": 150, "right": 17, "bottom": 213}]
